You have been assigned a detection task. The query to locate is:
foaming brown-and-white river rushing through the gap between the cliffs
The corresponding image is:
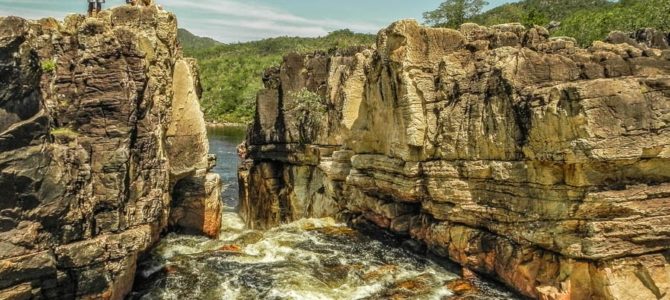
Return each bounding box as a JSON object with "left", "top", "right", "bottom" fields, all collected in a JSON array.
[{"left": 130, "top": 128, "right": 517, "bottom": 300}]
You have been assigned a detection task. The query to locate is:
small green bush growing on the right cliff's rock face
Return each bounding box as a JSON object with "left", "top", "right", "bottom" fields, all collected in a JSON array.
[{"left": 284, "top": 88, "right": 326, "bottom": 144}]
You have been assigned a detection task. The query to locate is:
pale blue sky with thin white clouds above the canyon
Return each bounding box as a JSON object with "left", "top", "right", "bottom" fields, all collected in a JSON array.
[{"left": 0, "top": 0, "right": 513, "bottom": 43}]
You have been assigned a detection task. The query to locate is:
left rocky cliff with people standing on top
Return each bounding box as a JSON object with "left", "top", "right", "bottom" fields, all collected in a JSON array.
[{"left": 0, "top": 6, "right": 220, "bottom": 299}]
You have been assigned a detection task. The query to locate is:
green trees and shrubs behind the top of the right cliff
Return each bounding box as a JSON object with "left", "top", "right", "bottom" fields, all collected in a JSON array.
[{"left": 425, "top": 0, "right": 670, "bottom": 46}]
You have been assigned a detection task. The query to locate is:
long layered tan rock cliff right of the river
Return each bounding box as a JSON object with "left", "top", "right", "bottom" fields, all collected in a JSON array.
[{"left": 240, "top": 21, "right": 670, "bottom": 299}]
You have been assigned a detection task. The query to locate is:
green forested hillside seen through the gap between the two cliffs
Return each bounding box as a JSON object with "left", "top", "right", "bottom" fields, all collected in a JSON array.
[{"left": 180, "top": 30, "right": 375, "bottom": 123}]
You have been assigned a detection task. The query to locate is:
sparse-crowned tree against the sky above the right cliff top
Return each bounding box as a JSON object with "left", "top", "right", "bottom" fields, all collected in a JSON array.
[{"left": 423, "top": 0, "right": 488, "bottom": 27}]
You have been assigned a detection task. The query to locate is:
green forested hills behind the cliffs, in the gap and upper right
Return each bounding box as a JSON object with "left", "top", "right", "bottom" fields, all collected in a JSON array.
[{"left": 179, "top": 0, "right": 670, "bottom": 123}]
